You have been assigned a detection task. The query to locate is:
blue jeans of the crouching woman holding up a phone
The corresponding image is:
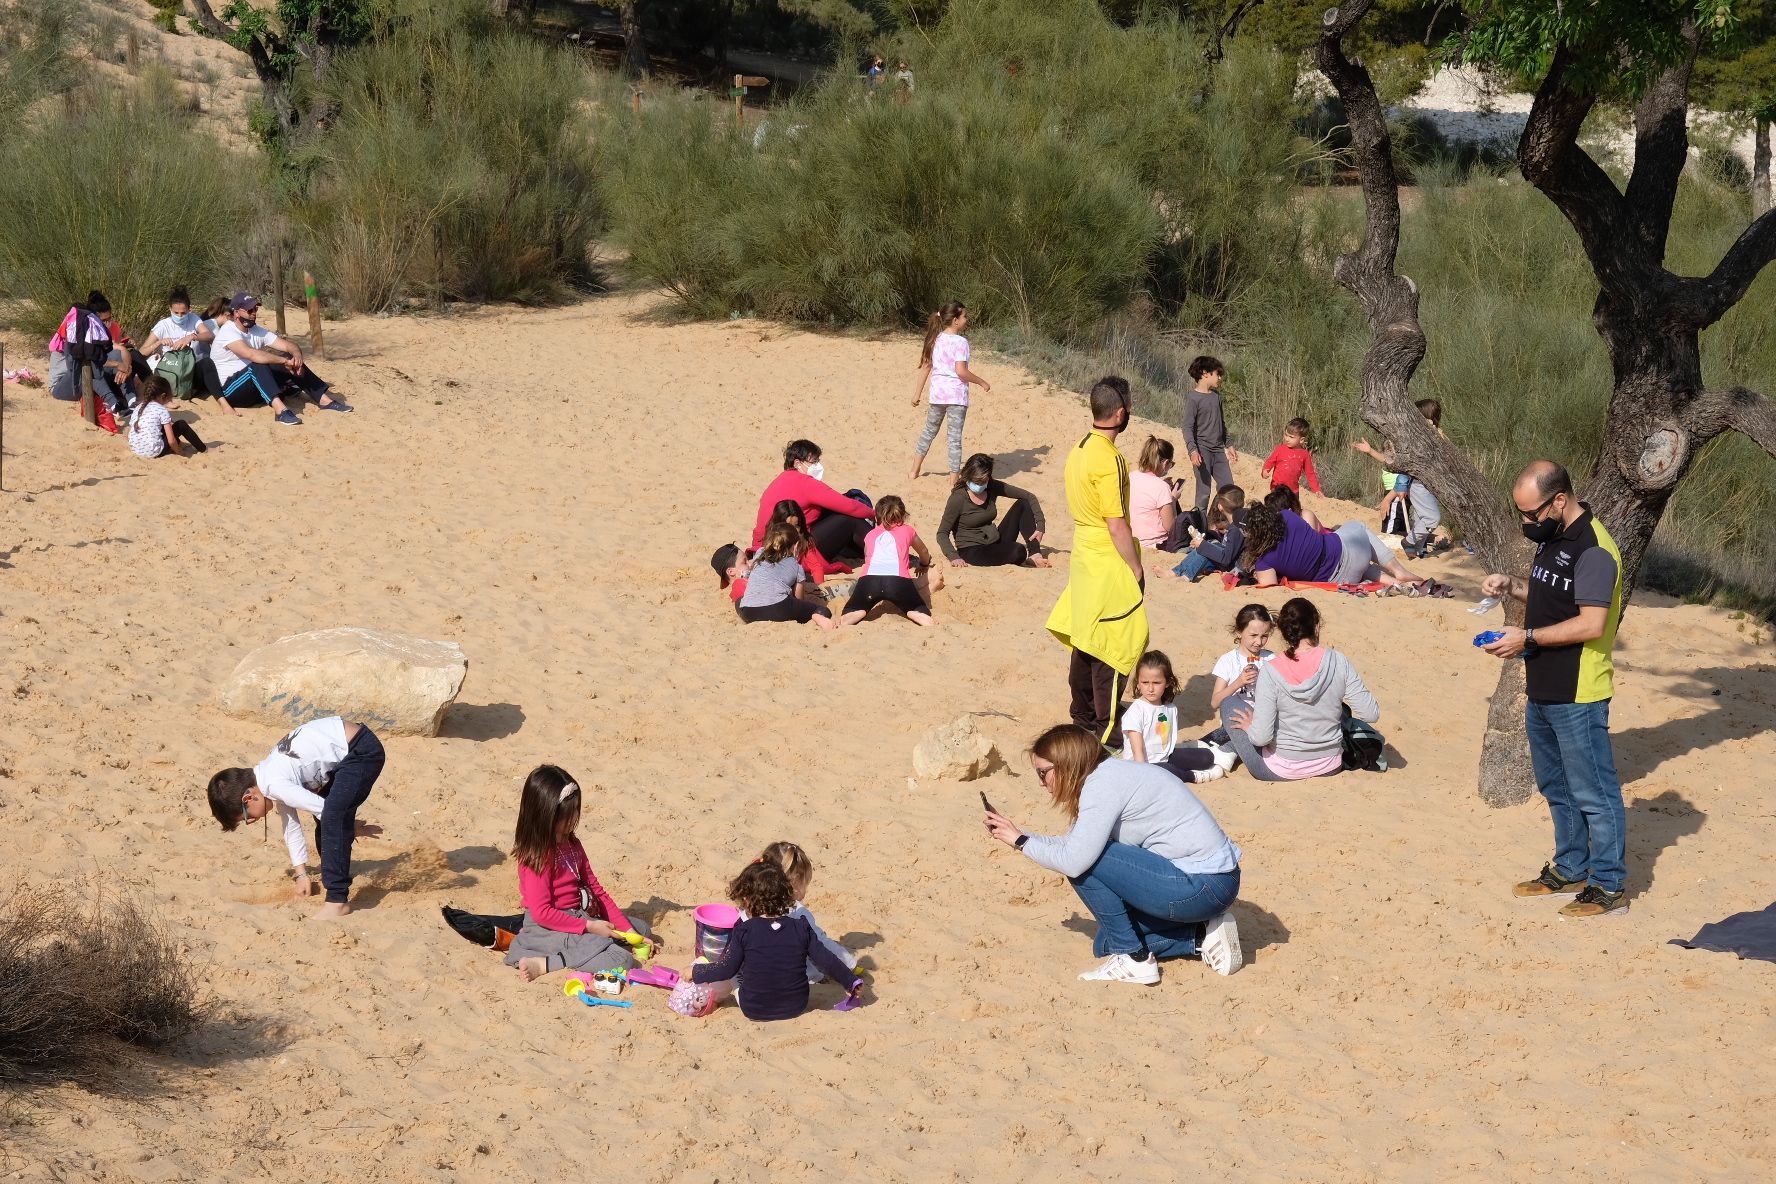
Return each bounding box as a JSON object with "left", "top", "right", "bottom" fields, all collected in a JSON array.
[{"left": 1071, "top": 843, "right": 1240, "bottom": 959}]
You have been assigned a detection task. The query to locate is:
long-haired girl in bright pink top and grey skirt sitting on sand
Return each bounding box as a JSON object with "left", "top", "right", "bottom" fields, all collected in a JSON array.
[{"left": 506, "top": 765, "right": 659, "bottom": 982}]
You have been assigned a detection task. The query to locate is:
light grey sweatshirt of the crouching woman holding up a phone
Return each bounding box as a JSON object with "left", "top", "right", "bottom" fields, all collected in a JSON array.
[{"left": 1023, "top": 760, "right": 1240, "bottom": 879}]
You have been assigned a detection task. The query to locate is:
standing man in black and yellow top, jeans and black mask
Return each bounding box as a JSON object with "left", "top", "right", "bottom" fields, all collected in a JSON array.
[{"left": 1483, "top": 460, "right": 1629, "bottom": 916}]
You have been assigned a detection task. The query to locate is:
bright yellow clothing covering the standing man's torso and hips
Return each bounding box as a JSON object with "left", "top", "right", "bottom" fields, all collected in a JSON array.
[{"left": 1048, "top": 431, "right": 1147, "bottom": 678}]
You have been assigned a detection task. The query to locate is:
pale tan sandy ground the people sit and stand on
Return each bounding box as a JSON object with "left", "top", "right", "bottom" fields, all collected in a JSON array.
[{"left": 0, "top": 295, "right": 1776, "bottom": 1182}]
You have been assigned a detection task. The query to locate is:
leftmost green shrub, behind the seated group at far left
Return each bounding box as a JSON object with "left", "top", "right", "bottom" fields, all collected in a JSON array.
[{"left": 0, "top": 85, "right": 259, "bottom": 337}]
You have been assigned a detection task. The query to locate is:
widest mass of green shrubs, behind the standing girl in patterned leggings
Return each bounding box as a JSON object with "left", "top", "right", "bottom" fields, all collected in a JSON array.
[{"left": 600, "top": 0, "right": 1302, "bottom": 343}]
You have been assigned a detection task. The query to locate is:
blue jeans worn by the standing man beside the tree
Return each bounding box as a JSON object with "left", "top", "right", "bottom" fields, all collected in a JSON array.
[{"left": 1524, "top": 699, "right": 1629, "bottom": 893}]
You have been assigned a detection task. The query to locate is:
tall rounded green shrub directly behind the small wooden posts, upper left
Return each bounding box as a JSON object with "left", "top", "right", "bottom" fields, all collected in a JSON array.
[{"left": 293, "top": 5, "right": 600, "bottom": 312}]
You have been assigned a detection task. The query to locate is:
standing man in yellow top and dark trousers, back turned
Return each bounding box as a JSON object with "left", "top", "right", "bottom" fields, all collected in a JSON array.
[{"left": 1048, "top": 376, "right": 1147, "bottom": 747}]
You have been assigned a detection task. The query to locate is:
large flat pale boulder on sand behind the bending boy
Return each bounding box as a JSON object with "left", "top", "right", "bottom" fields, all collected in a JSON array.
[{"left": 218, "top": 628, "right": 469, "bottom": 737}]
